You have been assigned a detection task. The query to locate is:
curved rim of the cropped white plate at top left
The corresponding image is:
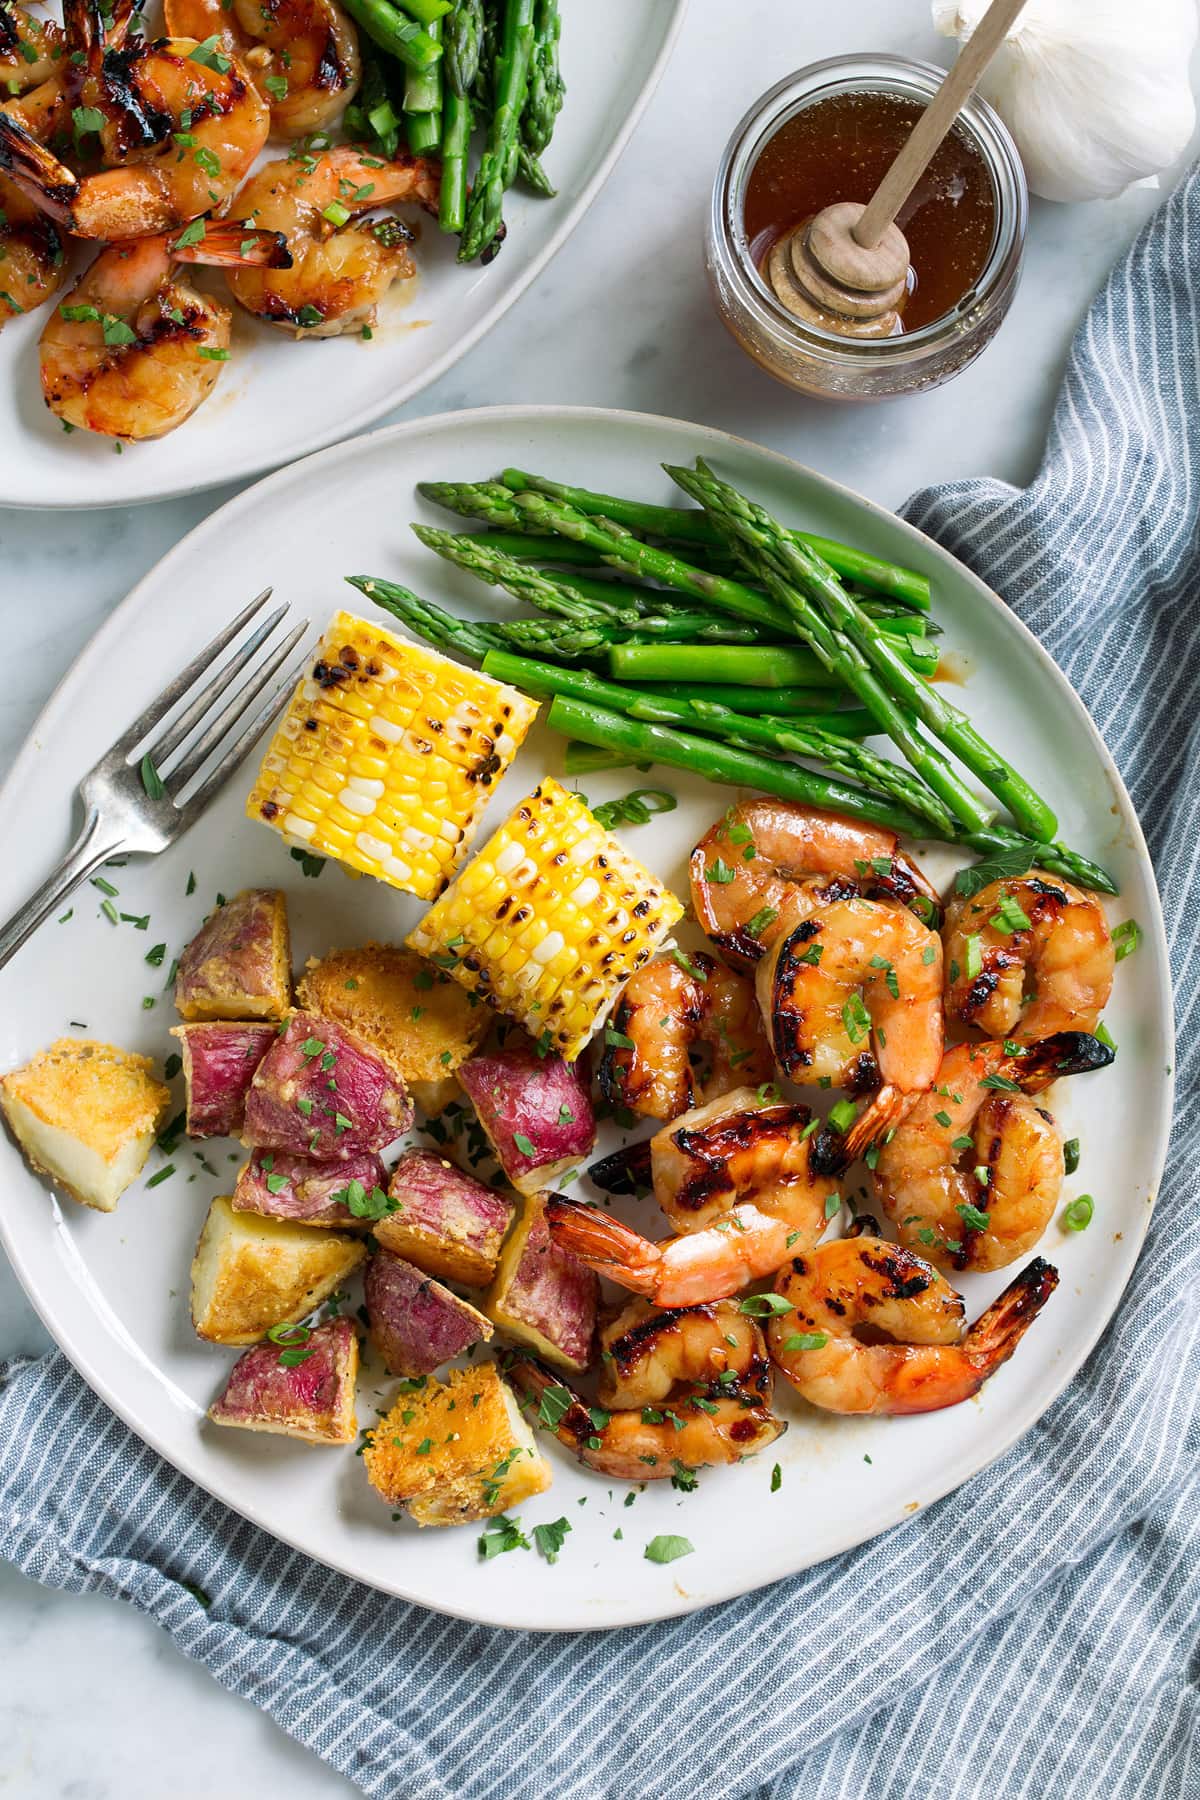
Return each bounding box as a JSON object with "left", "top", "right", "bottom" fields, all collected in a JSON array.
[{"left": 0, "top": 10, "right": 689, "bottom": 511}]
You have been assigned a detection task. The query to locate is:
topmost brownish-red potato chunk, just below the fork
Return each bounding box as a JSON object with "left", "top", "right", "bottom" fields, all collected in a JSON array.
[{"left": 175, "top": 887, "right": 291, "bottom": 1019}]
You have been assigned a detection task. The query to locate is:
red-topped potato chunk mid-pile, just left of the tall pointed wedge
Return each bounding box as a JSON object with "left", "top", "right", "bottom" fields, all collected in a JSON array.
[{"left": 374, "top": 1150, "right": 515, "bottom": 1287}]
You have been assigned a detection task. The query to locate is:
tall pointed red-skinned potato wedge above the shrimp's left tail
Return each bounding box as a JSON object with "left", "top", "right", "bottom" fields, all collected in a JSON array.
[{"left": 484, "top": 1193, "right": 599, "bottom": 1372}]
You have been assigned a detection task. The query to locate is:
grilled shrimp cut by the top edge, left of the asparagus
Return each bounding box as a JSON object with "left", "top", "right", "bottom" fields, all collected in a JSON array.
[{"left": 164, "top": 0, "right": 362, "bottom": 137}]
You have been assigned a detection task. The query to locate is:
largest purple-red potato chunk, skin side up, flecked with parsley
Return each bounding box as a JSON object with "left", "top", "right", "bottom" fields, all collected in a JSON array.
[{"left": 241, "top": 1013, "right": 412, "bottom": 1163}]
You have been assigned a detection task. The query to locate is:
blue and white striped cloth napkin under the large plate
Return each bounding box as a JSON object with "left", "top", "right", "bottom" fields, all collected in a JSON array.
[{"left": 0, "top": 171, "right": 1200, "bottom": 1800}]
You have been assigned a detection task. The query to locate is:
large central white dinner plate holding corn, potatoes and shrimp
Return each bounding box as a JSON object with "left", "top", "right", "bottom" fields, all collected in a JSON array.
[{"left": 0, "top": 407, "right": 1171, "bottom": 1629}]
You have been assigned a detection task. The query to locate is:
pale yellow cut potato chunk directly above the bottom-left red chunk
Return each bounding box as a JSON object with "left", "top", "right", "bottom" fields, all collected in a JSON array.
[{"left": 193, "top": 1195, "right": 367, "bottom": 1345}]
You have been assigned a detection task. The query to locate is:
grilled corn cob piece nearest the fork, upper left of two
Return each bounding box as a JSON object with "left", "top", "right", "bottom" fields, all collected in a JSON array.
[{"left": 246, "top": 612, "right": 538, "bottom": 900}]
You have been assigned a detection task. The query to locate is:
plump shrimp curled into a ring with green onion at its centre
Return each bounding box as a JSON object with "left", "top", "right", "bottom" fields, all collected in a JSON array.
[{"left": 756, "top": 877, "right": 943, "bottom": 1118}]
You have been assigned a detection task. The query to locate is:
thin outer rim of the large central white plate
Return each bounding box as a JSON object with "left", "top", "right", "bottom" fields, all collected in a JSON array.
[{"left": 0, "top": 405, "right": 1175, "bottom": 1631}]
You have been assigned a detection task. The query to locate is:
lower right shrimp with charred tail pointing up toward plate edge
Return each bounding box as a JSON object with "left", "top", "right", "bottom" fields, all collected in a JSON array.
[{"left": 766, "top": 1237, "right": 1058, "bottom": 1413}]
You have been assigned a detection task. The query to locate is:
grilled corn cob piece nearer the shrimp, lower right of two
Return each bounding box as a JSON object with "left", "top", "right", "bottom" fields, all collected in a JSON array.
[{"left": 407, "top": 778, "right": 684, "bottom": 1060}]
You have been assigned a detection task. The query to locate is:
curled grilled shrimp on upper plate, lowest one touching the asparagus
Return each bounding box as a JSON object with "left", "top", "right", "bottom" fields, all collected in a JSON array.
[{"left": 228, "top": 144, "right": 441, "bottom": 337}]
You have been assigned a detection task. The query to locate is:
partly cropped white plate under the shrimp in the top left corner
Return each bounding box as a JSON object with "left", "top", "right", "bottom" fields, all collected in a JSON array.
[{"left": 0, "top": 10, "right": 687, "bottom": 508}]
